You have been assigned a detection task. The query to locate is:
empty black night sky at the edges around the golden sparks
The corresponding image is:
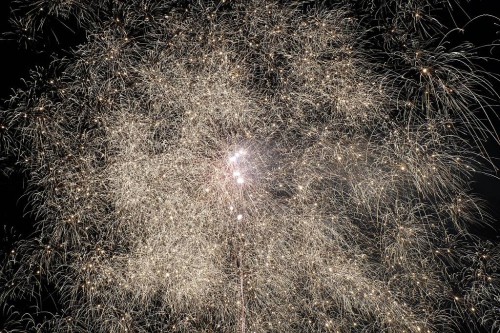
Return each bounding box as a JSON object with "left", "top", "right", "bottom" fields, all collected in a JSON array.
[{"left": 0, "top": 0, "right": 500, "bottom": 330}]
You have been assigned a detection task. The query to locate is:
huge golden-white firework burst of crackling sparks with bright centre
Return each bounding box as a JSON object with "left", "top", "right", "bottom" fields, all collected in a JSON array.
[{"left": 0, "top": 0, "right": 499, "bottom": 332}]
